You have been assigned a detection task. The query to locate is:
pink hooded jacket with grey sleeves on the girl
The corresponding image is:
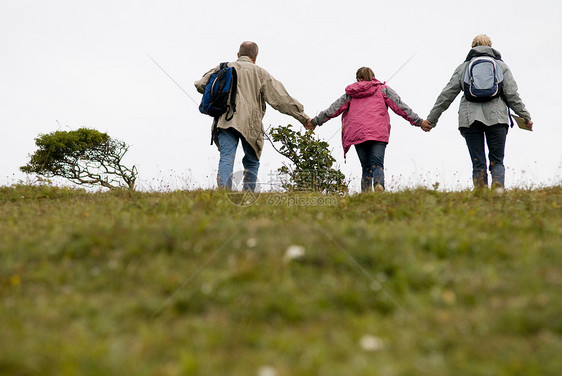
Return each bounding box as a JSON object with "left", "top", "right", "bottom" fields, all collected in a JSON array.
[{"left": 312, "top": 78, "right": 422, "bottom": 156}]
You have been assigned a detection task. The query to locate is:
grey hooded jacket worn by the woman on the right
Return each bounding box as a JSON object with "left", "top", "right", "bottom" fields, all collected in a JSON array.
[{"left": 427, "top": 46, "right": 531, "bottom": 128}]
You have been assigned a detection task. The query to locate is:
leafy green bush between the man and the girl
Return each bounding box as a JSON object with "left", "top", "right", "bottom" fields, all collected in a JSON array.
[{"left": 269, "top": 124, "right": 348, "bottom": 193}]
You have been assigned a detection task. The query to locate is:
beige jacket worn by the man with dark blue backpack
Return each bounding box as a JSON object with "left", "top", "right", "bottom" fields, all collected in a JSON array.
[{"left": 195, "top": 56, "right": 308, "bottom": 158}]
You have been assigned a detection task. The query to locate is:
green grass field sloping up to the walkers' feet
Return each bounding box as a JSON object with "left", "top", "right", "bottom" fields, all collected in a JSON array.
[{"left": 0, "top": 186, "right": 562, "bottom": 376}]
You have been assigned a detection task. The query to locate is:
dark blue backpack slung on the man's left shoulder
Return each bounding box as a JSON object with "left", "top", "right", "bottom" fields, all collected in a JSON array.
[{"left": 199, "top": 63, "right": 238, "bottom": 122}]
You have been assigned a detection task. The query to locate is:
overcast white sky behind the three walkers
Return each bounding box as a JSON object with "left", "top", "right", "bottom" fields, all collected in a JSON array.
[{"left": 0, "top": 0, "right": 562, "bottom": 190}]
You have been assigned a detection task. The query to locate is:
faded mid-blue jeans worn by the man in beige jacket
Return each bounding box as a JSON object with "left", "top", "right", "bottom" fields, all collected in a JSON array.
[{"left": 217, "top": 128, "right": 260, "bottom": 191}]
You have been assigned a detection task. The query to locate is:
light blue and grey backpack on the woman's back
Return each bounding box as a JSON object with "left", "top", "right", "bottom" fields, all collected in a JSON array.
[{"left": 463, "top": 56, "right": 503, "bottom": 102}]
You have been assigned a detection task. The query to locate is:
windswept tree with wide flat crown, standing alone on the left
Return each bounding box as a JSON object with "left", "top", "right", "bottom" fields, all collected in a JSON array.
[{"left": 20, "top": 128, "right": 137, "bottom": 189}]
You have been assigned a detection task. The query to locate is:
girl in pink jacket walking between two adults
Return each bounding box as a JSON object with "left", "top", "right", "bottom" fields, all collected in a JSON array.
[{"left": 307, "top": 67, "right": 423, "bottom": 192}]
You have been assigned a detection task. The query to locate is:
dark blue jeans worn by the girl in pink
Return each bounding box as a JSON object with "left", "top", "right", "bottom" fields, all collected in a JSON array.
[{"left": 355, "top": 141, "right": 387, "bottom": 192}]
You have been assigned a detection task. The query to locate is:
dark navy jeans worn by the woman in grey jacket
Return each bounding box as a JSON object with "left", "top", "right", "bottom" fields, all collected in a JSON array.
[{"left": 460, "top": 121, "right": 508, "bottom": 188}]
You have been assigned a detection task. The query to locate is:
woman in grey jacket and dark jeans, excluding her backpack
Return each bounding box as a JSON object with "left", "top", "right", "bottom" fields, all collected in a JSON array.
[{"left": 423, "top": 35, "right": 533, "bottom": 189}]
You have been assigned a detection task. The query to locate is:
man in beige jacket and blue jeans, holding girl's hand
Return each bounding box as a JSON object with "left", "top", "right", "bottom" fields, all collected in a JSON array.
[{"left": 191, "top": 42, "right": 309, "bottom": 191}]
